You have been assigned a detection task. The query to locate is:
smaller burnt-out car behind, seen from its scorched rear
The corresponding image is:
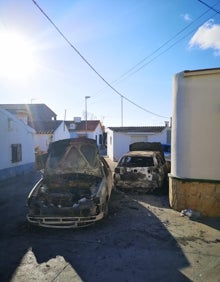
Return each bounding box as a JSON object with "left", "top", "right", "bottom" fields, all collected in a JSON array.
[{"left": 114, "top": 142, "right": 167, "bottom": 192}]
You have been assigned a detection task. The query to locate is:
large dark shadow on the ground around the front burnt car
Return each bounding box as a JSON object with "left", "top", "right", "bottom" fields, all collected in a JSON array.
[{"left": 0, "top": 173, "right": 190, "bottom": 282}]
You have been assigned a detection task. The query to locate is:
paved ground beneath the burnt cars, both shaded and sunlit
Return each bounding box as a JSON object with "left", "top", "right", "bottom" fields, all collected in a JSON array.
[{"left": 0, "top": 158, "right": 220, "bottom": 282}]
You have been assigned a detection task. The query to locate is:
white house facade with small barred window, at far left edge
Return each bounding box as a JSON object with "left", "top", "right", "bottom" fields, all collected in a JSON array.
[{"left": 0, "top": 107, "right": 35, "bottom": 180}]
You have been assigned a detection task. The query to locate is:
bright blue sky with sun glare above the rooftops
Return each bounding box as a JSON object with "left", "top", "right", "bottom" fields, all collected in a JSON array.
[{"left": 0, "top": 0, "right": 220, "bottom": 126}]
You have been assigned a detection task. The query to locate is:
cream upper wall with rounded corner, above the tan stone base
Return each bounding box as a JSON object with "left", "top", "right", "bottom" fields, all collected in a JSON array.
[{"left": 171, "top": 69, "right": 220, "bottom": 180}]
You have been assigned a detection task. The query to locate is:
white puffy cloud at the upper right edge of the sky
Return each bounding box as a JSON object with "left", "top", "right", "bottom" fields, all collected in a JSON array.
[{"left": 189, "top": 20, "right": 220, "bottom": 55}]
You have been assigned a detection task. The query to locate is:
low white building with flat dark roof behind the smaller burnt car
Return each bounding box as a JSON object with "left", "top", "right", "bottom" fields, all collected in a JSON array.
[{"left": 107, "top": 123, "right": 171, "bottom": 161}]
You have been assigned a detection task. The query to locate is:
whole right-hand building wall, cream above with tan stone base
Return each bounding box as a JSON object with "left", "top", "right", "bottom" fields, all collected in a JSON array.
[{"left": 169, "top": 69, "right": 220, "bottom": 216}]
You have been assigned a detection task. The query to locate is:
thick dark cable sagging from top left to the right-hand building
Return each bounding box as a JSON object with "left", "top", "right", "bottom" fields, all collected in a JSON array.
[{"left": 32, "top": 0, "right": 169, "bottom": 118}]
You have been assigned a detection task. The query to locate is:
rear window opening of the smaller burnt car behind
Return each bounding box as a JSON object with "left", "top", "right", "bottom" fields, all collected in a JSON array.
[{"left": 119, "top": 156, "right": 154, "bottom": 167}]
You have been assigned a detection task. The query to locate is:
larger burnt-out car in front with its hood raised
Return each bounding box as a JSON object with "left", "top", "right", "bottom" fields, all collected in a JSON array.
[{"left": 27, "top": 138, "right": 112, "bottom": 228}]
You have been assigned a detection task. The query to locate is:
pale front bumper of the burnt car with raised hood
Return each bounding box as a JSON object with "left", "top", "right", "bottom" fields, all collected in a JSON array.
[{"left": 27, "top": 212, "right": 104, "bottom": 228}]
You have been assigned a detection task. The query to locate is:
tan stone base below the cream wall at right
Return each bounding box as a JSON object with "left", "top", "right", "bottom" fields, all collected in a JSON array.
[{"left": 169, "top": 176, "right": 220, "bottom": 217}]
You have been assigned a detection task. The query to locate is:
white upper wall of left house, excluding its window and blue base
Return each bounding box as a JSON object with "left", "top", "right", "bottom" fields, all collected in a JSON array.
[{"left": 0, "top": 108, "right": 35, "bottom": 170}]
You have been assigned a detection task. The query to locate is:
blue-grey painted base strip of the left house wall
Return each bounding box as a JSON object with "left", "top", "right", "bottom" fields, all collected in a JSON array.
[{"left": 0, "top": 163, "right": 35, "bottom": 181}]
